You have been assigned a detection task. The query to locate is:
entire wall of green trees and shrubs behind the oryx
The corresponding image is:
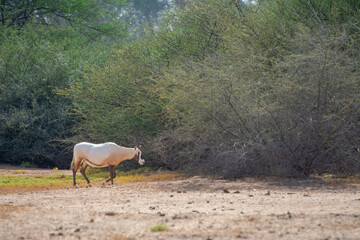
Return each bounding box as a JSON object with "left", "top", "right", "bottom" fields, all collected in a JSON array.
[{"left": 0, "top": 0, "right": 360, "bottom": 178}]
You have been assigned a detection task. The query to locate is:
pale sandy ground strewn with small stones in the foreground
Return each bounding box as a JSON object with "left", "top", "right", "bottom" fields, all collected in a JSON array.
[{"left": 0, "top": 170, "right": 360, "bottom": 240}]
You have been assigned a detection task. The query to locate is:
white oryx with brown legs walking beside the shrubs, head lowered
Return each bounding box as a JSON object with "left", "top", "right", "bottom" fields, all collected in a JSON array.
[{"left": 70, "top": 142, "right": 145, "bottom": 187}]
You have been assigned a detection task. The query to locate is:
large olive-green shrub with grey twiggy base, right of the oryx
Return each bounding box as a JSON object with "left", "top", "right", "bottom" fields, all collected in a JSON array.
[{"left": 150, "top": 1, "right": 360, "bottom": 178}]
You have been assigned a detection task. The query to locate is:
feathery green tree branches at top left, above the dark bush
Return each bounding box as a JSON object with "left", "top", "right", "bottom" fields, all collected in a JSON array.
[{"left": 0, "top": 0, "right": 127, "bottom": 37}]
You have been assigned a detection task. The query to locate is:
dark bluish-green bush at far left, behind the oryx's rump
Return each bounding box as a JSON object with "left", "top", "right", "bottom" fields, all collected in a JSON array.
[{"left": 0, "top": 25, "right": 114, "bottom": 167}]
